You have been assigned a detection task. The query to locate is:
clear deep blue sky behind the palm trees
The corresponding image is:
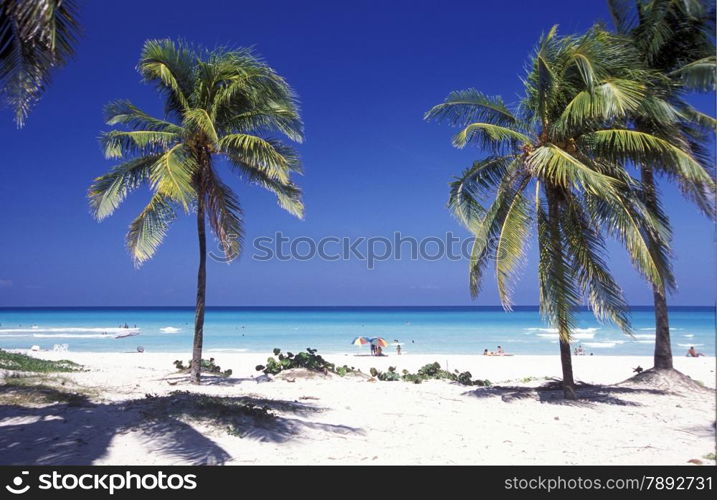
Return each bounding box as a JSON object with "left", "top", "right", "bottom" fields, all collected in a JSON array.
[{"left": 0, "top": 0, "right": 715, "bottom": 306}]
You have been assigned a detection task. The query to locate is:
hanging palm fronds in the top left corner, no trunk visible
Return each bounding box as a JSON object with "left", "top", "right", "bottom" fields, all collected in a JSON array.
[{"left": 0, "top": 0, "right": 78, "bottom": 127}]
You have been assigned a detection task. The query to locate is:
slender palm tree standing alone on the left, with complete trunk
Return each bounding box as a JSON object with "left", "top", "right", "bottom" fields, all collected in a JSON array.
[{"left": 88, "top": 40, "right": 303, "bottom": 383}]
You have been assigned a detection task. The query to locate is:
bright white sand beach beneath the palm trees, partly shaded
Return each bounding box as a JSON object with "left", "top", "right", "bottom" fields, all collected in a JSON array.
[{"left": 0, "top": 353, "right": 715, "bottom": 464}]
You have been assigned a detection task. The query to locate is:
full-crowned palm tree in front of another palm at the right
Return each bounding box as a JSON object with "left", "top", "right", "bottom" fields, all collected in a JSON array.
[{"left": 426, "top": 28, "right": 701, "bottom": 398}]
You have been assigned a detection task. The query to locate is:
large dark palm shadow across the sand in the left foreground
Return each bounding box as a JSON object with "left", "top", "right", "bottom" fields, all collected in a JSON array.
[{"left": 0, "top": 385, "right": 363, "bottom": 465}]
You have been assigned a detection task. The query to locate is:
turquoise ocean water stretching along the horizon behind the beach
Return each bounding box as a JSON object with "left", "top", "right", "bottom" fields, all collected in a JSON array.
[{"left": 0, "top": 307, "right": 715, "bottom": 356}]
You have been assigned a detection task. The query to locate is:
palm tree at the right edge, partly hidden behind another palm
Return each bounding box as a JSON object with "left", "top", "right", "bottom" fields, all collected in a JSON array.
[{"left": 608, "top": 0, "right": 716, "bottom": 370}]
